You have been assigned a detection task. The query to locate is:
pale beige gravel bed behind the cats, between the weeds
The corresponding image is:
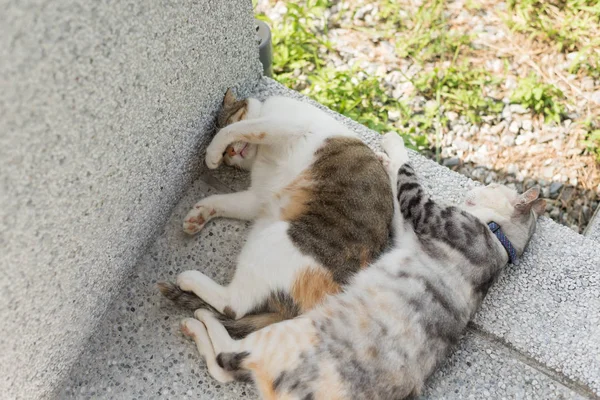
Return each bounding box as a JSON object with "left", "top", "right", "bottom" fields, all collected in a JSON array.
[{"left": 257, "top": 0, "right": 600, "bottom": 232}]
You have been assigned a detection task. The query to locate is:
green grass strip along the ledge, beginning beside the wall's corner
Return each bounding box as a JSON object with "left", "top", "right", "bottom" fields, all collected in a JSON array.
[{"left": 260, "top": 0, "right": 427, "bottom": 149}]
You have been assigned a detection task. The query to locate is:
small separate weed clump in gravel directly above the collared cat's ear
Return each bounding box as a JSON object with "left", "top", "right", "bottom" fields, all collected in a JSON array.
[{"left": 510, "top": 74, "right": 565, "bottom": 122}]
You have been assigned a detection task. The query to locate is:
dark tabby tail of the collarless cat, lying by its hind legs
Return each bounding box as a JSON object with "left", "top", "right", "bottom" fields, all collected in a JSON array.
[{"left": 157, "top": 282, "right": 298, "bottom": 339}]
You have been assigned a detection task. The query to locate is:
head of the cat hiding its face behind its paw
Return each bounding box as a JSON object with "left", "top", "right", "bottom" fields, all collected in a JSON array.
[{"left": 217, "top": 89, "right": 258, "bottom": 170}]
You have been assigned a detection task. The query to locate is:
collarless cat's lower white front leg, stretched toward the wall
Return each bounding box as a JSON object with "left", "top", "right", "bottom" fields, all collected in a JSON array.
[{"left": 183, "top": 190, "right": 259, "bottom": 235}]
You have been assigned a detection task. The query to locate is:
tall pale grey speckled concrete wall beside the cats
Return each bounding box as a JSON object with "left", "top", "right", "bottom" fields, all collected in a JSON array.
[{"left": 0, "top": 0, "right": 262, "bottom": 399}]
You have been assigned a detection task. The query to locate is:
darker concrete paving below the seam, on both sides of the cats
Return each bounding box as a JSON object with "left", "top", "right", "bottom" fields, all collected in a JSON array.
[{"left": 56, "top": 169, "right": 586, "bottom": 400}]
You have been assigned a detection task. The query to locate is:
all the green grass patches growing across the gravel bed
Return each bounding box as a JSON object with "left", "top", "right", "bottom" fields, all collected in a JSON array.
[{"left": 258, "top": 0, "right": 600, "bottom": 159}]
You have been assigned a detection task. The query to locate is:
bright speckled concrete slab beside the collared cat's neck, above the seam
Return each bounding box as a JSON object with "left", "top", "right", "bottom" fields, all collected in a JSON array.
[{"left": 475, "top": 219, "right": 600, "bottom": 395}]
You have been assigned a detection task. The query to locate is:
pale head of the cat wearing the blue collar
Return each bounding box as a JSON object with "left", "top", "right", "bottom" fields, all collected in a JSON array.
[{"left": 463, "top": 183, "right": 546, "bottom": 255}]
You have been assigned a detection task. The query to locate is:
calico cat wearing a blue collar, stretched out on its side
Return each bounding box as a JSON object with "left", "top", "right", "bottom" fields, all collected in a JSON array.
[{"left": 181, "top": 133, "right": 545, "bottom": 400}]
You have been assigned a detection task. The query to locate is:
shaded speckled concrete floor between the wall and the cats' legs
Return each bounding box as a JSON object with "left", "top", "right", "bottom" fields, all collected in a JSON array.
[{"left": 55, "top": 179, "right": 256, "bottom": 400}]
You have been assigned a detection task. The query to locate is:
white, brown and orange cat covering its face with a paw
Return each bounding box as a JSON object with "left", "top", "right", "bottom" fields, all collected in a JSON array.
[{"left": 159, "top": 91, "right": 394, "bottom": 338}]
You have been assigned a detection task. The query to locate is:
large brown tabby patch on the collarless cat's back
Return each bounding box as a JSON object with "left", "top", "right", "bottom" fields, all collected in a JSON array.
[{"left": 281, "top": 136, "right": 394, "bottom": 284}]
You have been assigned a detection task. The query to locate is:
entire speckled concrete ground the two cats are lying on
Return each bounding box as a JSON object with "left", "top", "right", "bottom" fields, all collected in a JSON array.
[{"left": 56, "top": 79, "right": 600, "bottom": 399}]
